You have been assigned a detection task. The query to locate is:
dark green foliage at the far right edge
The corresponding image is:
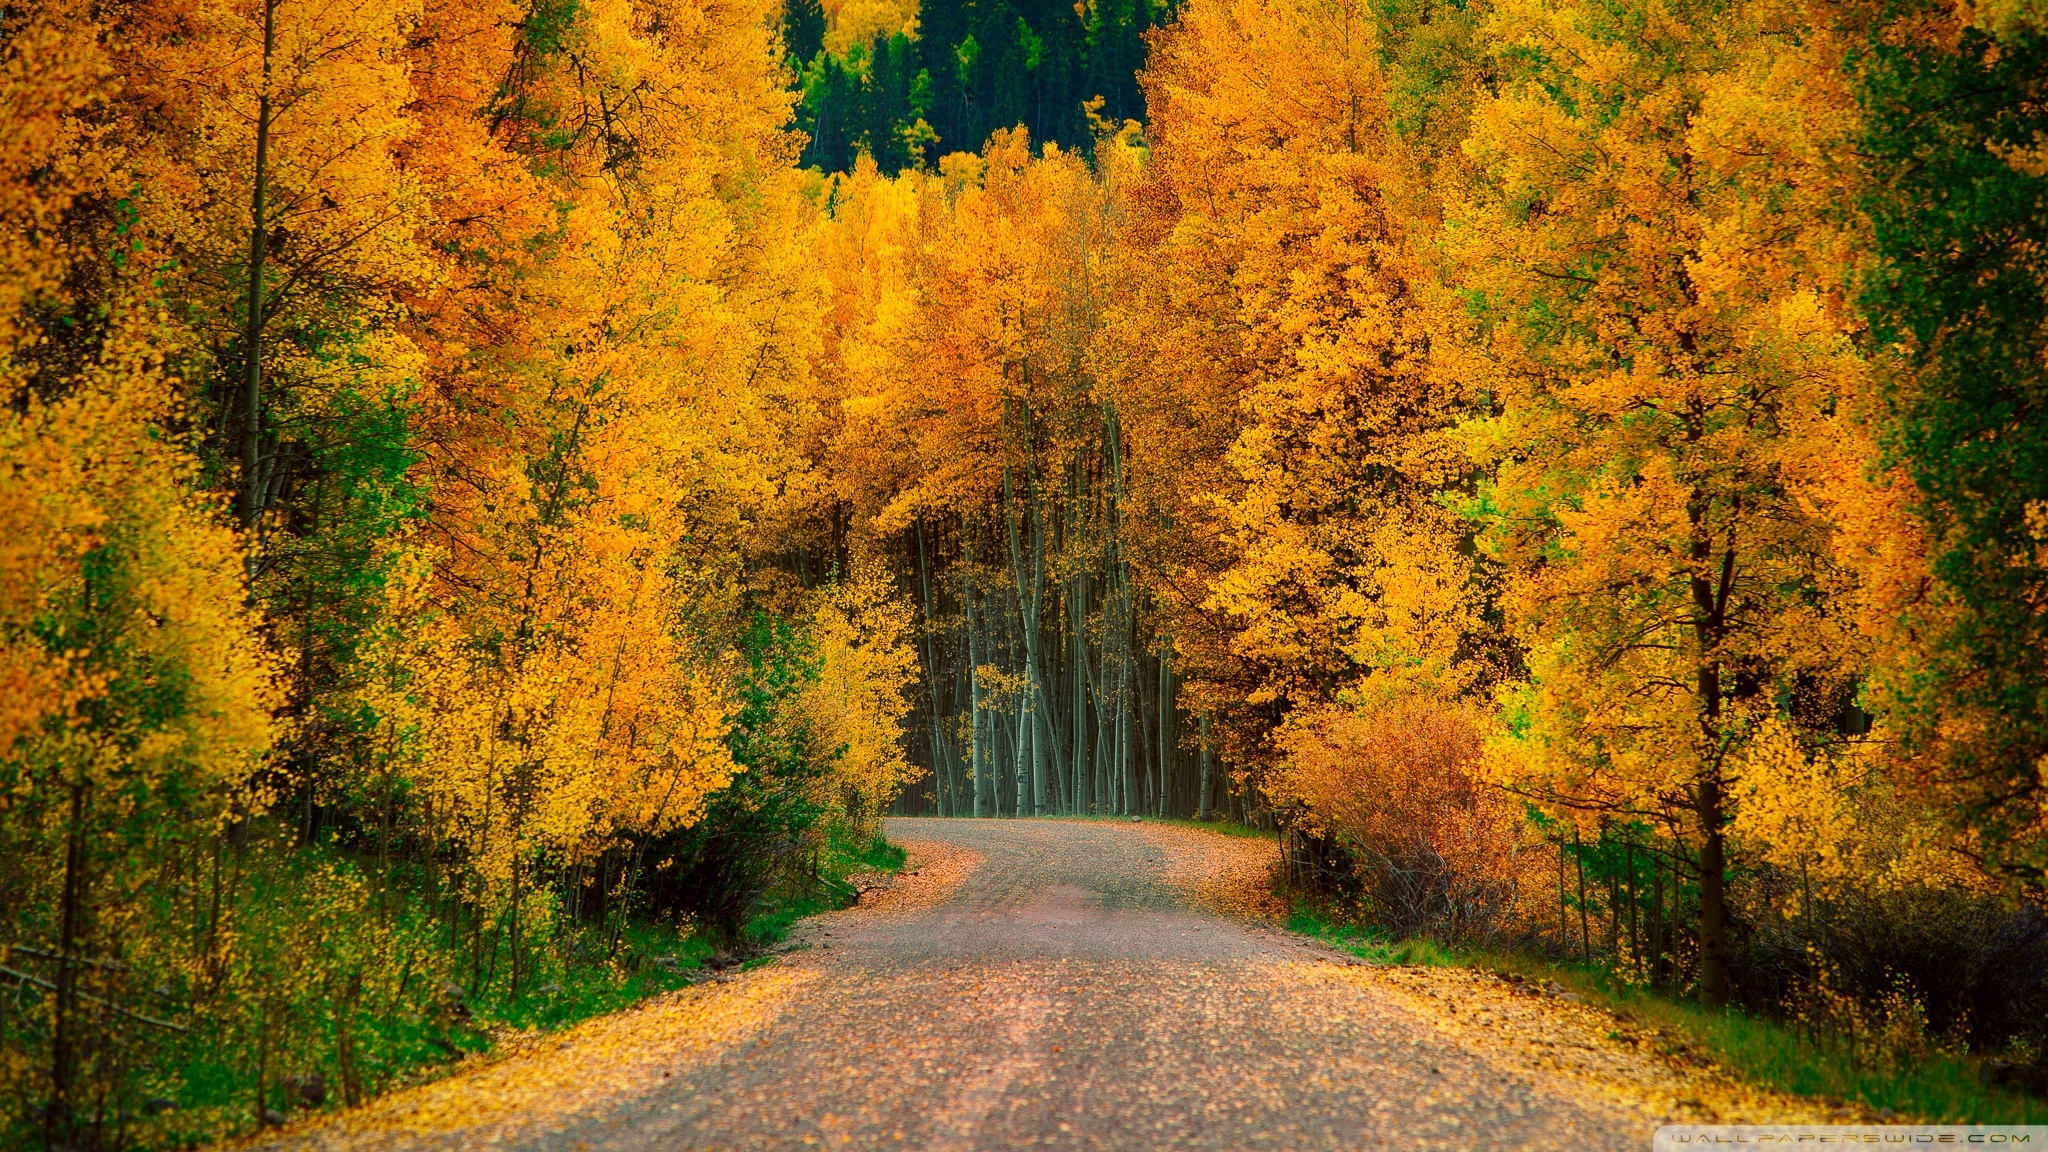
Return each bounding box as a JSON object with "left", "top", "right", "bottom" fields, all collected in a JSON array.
[{"left": 1855, "top": 6, "right": 2048, "bottom": 890}]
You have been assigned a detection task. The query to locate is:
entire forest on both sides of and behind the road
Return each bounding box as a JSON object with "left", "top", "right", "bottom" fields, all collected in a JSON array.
[{"left": 0, "top": 0, "right": 2048, "bottom": 1146}]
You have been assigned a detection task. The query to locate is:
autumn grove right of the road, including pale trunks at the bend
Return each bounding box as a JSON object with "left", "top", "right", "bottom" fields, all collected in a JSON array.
[{"left": 786, "top": 0, "right": 2048, "bottom": 1082}]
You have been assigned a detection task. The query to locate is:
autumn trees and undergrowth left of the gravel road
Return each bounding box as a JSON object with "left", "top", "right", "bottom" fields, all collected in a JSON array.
[{"left": 0, "top": 0, "right": 911, "bottom": 1148}]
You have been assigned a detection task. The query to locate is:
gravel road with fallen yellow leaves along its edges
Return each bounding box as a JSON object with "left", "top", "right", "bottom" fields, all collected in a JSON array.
[{"left": 247, "top": 820, "right": 1827, "bottom": 1152}]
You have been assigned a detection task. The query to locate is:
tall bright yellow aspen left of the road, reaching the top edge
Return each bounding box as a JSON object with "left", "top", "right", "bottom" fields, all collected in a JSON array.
[{"left": 360, "top": 2, "right": 813, "bottom": 967}]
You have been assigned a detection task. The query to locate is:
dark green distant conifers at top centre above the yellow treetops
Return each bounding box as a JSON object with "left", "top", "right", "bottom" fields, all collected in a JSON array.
[{"left": 784, "top": 0, "right": 1171, "bottom": 176}]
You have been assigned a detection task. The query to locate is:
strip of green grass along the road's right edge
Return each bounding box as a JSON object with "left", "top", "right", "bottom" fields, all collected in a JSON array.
[{"left": 1288, "top": 910, "right": 2048, "bottom": 1123}]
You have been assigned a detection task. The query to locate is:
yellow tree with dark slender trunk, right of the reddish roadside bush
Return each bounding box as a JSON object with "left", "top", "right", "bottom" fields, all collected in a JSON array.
[{"left": 1448, "top": 0, "right": 1864, "bottom": 1002}]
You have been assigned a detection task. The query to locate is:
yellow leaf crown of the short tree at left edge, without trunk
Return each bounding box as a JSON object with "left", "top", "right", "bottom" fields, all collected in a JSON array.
[{"left": 0, "top": 312, "right": 276, "bottom": 804}]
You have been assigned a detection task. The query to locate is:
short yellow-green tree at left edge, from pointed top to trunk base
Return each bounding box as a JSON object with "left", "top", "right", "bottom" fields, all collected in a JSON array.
[{"left": 0, "top": 305, "right": 276, "bottom": 1142}]
